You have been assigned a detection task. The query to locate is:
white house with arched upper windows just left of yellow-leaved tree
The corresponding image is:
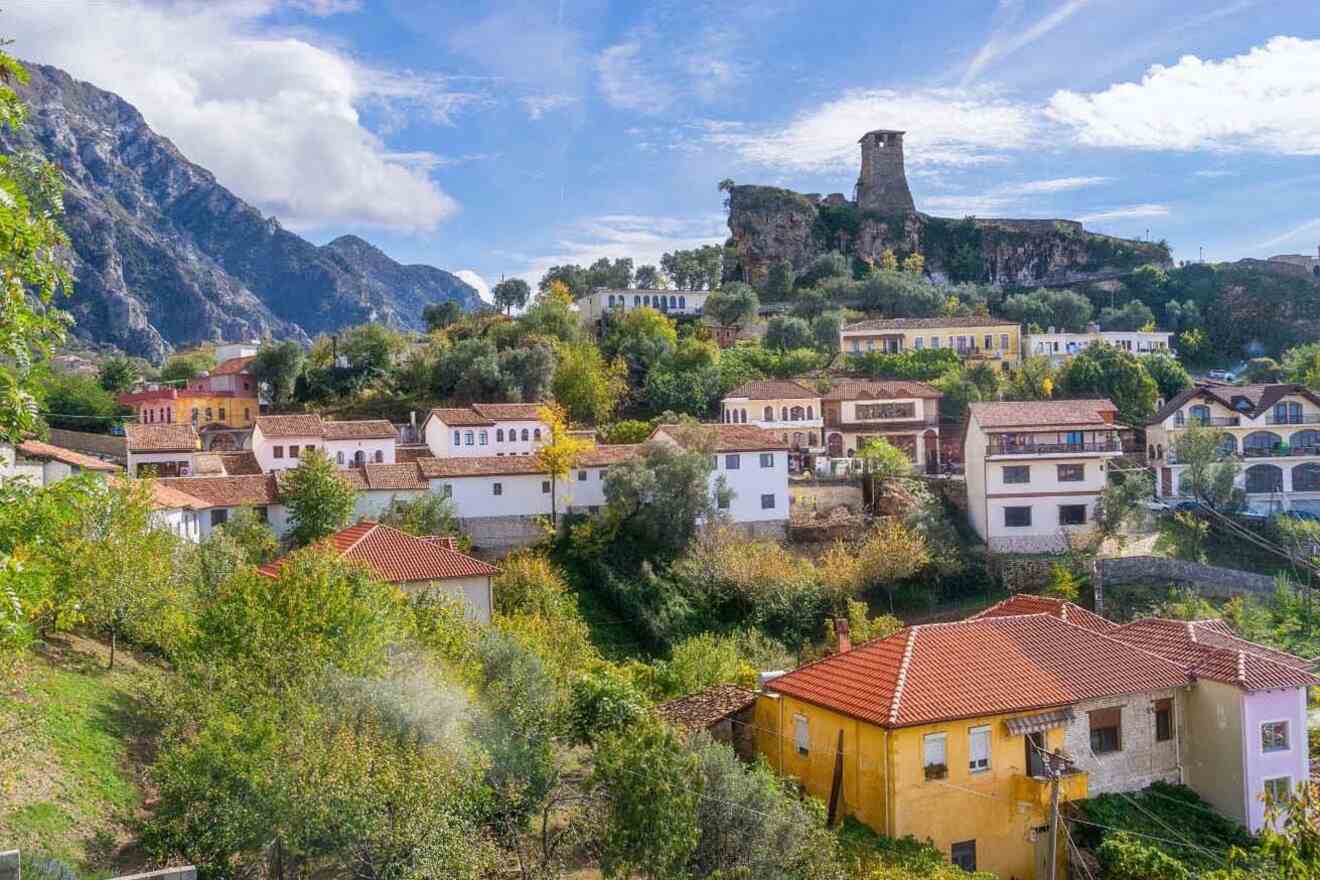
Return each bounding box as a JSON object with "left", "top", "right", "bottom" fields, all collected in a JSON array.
[{"left": 421, "top": 404, "right": 550, "bottom": 458}]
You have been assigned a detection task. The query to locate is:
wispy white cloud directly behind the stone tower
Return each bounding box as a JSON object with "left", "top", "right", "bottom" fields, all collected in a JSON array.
[{"left": 706, "top": 88, "right": 1039, "bottom": 172}]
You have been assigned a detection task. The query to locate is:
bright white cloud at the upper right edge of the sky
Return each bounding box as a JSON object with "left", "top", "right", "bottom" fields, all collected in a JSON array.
[{"left": 1048, "top": 37, "right": 1320, "bottom": 156}]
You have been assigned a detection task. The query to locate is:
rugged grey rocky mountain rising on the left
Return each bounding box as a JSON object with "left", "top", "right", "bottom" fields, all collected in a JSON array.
[{"left": 0, "top": 65, "right": 479, "bottom": 360}]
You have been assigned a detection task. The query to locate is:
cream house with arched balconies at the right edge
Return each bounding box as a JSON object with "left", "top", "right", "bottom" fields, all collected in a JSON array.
[{"left": 1146, "top": 383, "right": 1320, "bottom": 513}]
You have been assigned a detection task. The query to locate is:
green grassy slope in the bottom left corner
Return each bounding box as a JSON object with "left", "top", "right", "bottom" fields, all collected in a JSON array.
[{"left": 0, "top": 636, "right": 161, "bottom": 873}]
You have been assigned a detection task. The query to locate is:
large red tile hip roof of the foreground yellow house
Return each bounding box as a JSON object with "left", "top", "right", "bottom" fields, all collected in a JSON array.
[{"left": 766, "top": 613, "right": 1187, "bottom": 727}]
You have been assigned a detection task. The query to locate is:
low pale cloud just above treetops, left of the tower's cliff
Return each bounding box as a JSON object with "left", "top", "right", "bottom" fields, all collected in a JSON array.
[{"left": 510, "top": 214, "right": 729, "bottom": 286}]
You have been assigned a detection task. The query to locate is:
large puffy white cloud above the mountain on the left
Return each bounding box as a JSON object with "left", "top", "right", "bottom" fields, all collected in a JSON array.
[{"left": 5, "top": 0, "right": 479, "bottom": 230}]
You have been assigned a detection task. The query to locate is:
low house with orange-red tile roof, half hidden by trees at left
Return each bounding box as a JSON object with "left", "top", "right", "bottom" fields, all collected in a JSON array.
[{"left": 259, "top": 520, "right": 499, "bottom": 623}]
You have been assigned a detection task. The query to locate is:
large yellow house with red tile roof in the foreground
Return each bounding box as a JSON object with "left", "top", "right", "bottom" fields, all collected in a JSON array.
[{"left": 754, "top": 603, "right": 1188, "bottom": 880}]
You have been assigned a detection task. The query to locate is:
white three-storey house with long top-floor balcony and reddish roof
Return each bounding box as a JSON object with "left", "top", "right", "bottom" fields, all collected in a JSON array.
[{"left": 962, "top": 400, "right": 1123, "bottom": 553}]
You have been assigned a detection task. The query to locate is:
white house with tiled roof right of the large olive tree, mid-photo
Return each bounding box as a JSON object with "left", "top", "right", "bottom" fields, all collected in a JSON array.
[{"left": 651, "top": 425, "right": 789, "bottom": 537}]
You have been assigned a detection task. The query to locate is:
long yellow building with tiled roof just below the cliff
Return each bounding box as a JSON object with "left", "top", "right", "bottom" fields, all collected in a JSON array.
[{"left": 838, "top": 315, "right": 1022, "bottom": 369}]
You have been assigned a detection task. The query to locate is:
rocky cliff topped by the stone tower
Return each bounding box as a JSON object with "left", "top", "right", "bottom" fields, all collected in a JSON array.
[{"left": 726, "top": 186, "right": 1168, "bottom": 286}]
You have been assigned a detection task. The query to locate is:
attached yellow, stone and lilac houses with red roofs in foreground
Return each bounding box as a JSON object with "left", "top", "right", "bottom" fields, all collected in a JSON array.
[{"left": 752, "top": 596, "right": 1320, "bottom": 880}]
